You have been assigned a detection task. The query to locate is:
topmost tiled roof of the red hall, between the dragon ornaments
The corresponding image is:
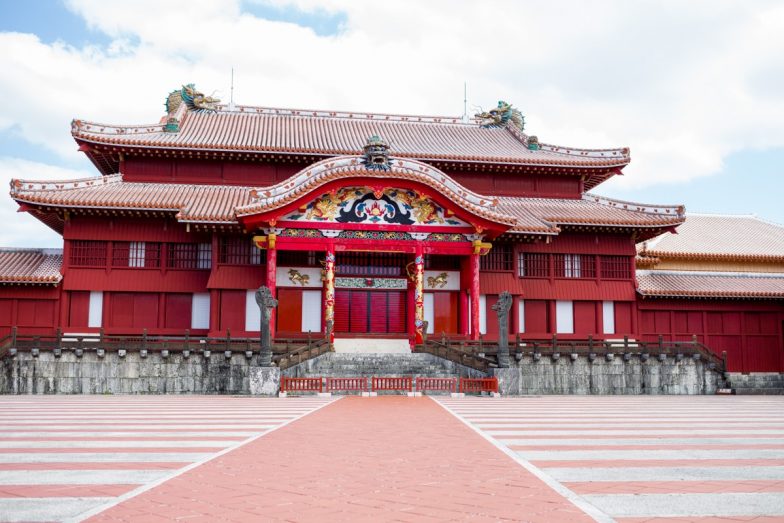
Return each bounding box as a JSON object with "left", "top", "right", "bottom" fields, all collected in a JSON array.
[{"left": 71, "top": 106, "right": 630, "bottom": 169}]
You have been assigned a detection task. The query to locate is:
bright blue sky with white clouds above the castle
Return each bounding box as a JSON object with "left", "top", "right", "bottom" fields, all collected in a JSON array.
[{"left": 0, "top": 0, "right": 784, "bottom": 247}]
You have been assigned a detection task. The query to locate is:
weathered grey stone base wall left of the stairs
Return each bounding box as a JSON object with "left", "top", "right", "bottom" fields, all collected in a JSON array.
[{"left": 0, "top": 350, "right": 279, "bottom": 395}]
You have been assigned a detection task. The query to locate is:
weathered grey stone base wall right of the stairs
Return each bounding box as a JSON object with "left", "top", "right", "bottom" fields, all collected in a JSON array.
[{"left": 494, "top": 354, "right": 724, "bottom": 396}]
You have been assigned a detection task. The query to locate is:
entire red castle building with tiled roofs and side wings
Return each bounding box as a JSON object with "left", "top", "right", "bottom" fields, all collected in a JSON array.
[{"left": 0, "top": 85, "right": 784, "bottom": 372}]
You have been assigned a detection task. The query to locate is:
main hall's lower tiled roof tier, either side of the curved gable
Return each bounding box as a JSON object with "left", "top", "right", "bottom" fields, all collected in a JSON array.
[{"left": 11, "top": 175, "right": 683, "bottom": 234}]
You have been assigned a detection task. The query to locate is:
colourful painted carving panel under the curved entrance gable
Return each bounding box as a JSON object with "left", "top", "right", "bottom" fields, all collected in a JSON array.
[{"left": 282, "top": 187, "right": 469, "bottom": 227}]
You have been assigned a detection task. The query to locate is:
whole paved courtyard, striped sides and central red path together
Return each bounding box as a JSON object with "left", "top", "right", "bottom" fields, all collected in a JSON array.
[{"left": 0, "top": 396, "right": 784, "bottom": 523}]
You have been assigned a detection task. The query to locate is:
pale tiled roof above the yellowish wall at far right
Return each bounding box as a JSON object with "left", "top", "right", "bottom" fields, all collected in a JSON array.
[{"left": 637, "top": 214, "right": 784, "bottom": 262}]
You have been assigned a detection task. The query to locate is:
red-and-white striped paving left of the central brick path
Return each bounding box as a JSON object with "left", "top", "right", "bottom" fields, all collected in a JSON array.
[{"left": 0, "top": 396, "right": 333, "bottom": 522}]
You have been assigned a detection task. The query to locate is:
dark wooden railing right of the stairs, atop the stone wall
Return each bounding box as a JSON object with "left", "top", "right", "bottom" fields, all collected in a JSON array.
[{"left": 416, "top": 335, "right": 727, "bottom": 372}]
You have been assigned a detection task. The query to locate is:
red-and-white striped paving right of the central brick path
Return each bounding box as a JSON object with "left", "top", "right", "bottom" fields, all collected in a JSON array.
[{"left": 438, "top": 396, "right": 784, "bottom": 521}]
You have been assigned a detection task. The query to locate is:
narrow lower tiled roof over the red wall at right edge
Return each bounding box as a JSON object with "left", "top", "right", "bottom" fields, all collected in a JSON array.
[{"left": 637, "top": 271, "right": 784, "bottom": 298}]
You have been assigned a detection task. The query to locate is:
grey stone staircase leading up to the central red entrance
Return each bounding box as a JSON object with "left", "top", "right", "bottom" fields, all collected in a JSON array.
[{"left": 283, "top": 352, "right": 486, "bottom": 378}]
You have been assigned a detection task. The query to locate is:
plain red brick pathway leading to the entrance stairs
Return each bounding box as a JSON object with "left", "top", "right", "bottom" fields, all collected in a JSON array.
[{"left": 89, "top": 397, "right": 593, "bottom": 523}]
